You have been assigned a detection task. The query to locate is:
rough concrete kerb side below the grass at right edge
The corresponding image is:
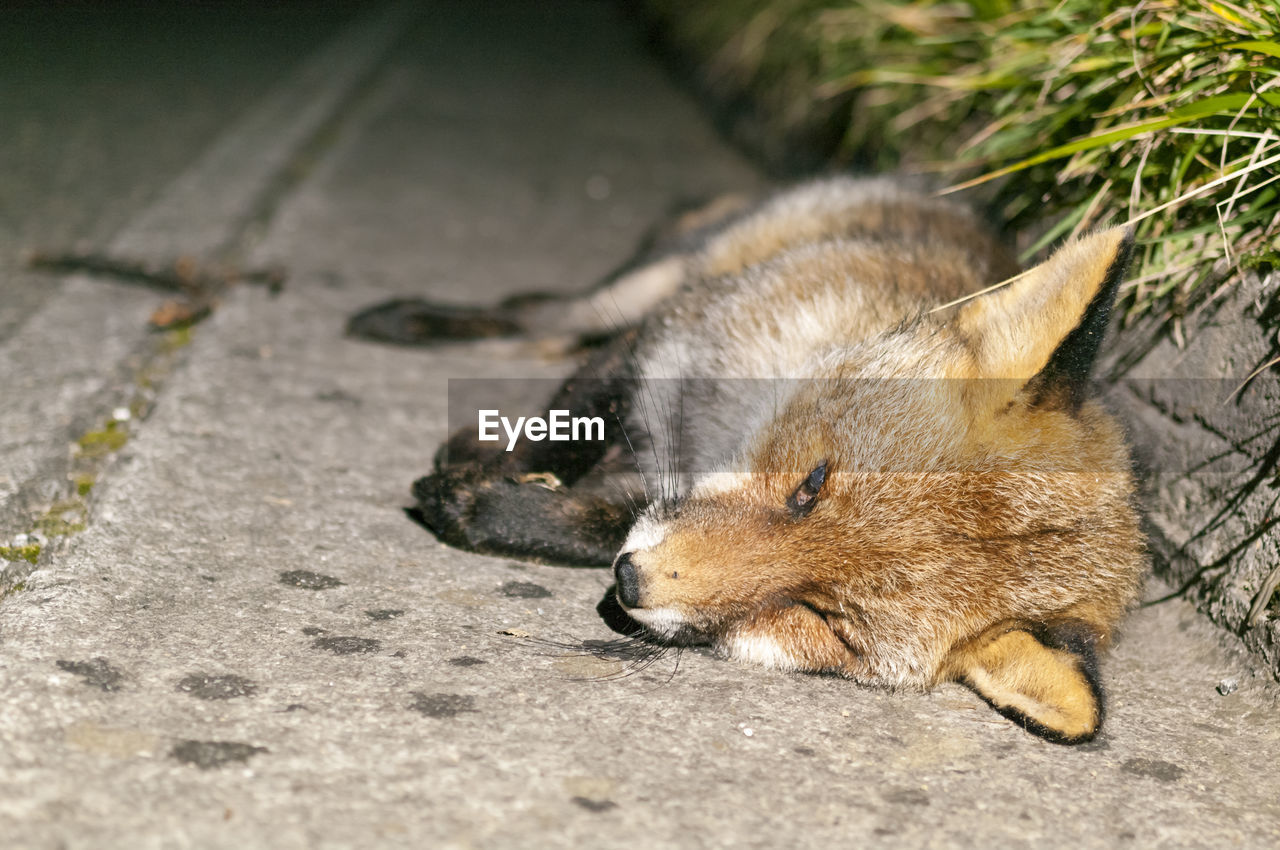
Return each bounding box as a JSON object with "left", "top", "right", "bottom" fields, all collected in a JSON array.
[{"left": 1111, "top": 271, "right": 1280, "bottom": 676}]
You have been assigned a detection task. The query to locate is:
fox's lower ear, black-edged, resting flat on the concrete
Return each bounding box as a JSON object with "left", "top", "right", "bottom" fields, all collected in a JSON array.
[{"left": 946, "top": 621, "right": 1103, "bottom": 744}]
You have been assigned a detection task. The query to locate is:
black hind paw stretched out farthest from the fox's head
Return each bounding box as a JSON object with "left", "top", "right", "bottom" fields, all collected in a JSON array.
[{"left": 347, "top": 298, "right": 524, "bottom": 346}]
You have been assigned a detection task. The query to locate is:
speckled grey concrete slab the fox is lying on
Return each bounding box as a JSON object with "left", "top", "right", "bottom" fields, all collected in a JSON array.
[{"left": 0, "top": 3, "right": 1280, "bottom": 847}]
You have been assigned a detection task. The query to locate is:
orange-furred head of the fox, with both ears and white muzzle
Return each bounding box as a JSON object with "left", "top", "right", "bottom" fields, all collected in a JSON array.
[{"left": 614, "top": 229, "right": 1144, "bottom": 742}]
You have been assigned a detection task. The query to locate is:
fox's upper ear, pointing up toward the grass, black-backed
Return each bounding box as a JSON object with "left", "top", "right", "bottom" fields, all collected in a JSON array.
[{"left": 955, "top": 228, "right": 1133, "bottom": 407}]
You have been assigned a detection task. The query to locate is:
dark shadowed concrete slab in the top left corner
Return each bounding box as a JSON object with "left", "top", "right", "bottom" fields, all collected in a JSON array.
[{"left": 0, "top": 0, "right": 360, "bottom": 342}]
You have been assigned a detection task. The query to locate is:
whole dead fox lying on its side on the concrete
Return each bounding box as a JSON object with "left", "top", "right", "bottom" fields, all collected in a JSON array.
[{"left": 351, "top": 178, "right": 1146, "bottom": 744}]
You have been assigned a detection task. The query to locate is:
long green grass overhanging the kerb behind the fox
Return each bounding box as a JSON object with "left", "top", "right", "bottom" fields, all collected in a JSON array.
[{"left": 648, "top": 0, "right": 1280, "bottom": 325}]
